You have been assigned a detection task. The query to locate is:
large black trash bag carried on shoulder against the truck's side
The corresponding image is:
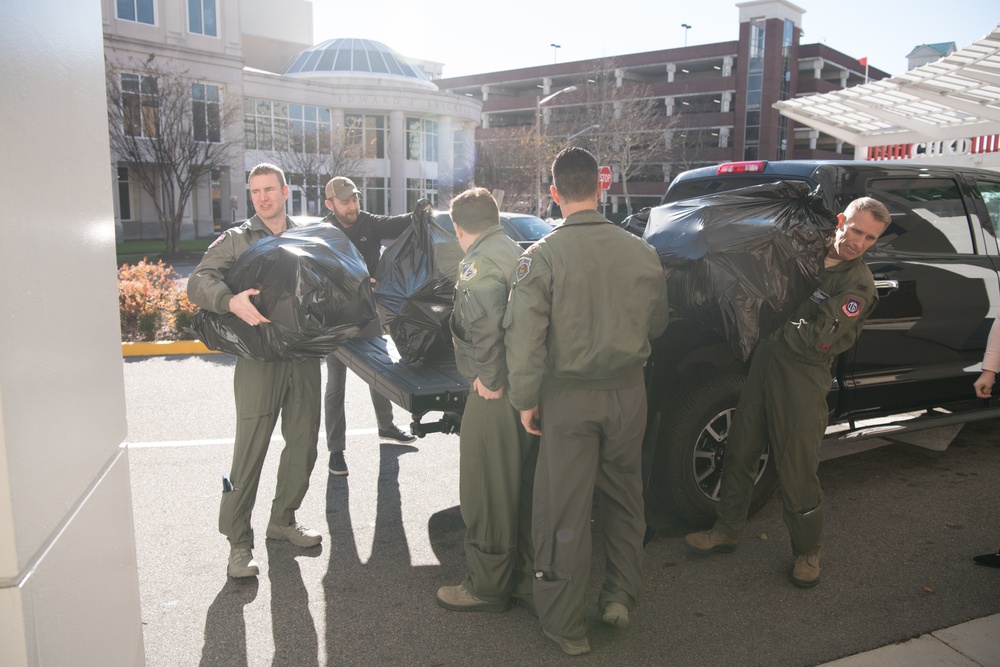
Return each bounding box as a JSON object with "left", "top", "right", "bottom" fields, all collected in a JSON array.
[{"left": 643, "top": 181, "right": 837, "bottom": 360}]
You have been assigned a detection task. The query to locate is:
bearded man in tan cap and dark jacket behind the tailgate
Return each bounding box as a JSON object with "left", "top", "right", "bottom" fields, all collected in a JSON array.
[{"left": 323, "top": 176, "right": 426, "bottom": 475}]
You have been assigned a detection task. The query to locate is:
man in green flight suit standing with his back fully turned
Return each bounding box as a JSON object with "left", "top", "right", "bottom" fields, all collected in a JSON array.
[{"left": 504, "top": 147, "right": 667, "bottom": 655}]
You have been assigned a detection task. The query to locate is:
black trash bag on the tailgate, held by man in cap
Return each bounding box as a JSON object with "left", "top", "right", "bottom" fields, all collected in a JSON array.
[{"left": 375, "top": 204, "right": 464, "bottom": 363}]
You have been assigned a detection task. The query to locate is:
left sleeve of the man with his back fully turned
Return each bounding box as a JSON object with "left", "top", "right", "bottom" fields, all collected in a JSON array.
[{"left": 504, "top": 251, "right": 556, "bottom": 410}]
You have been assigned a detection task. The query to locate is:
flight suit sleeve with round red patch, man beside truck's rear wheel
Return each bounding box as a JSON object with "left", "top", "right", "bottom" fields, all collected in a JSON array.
[{"left": 781, "top": 276, "right": 876, "bottom": 361}]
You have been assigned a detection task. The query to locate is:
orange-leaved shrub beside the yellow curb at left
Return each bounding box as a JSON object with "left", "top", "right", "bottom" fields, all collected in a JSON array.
[{"left": 118, "top": 260, "right": 198, "bottom": 341}]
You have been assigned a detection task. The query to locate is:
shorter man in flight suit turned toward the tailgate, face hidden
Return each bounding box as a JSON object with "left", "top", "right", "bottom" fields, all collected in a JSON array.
[{"left": 437, "top": 188, "right": 538, "bottom": 611}]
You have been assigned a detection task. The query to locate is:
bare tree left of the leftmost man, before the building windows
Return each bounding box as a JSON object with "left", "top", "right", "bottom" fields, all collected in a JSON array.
[{"left": 106, "top": 55, "right": 243, "bottom": 253}]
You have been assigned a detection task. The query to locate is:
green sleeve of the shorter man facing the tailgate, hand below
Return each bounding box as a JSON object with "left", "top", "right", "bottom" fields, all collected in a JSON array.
[{"left": 455, "top": 266, "right": 507, "bottom": 391}]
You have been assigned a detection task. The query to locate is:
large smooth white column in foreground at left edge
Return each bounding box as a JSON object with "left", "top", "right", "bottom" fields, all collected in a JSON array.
[{"left": 0, "top": 0, "right": 143, "bottom": 667}]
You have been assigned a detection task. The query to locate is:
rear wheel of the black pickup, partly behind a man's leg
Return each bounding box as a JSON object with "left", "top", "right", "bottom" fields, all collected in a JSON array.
[{"left": 651, "top": 371, "right": 778, "bottom": 527}]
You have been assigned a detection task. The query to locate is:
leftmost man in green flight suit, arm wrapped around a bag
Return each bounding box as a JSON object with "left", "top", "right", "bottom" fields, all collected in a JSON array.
[{"left": 188, "top": 163, "right": 322, "bottom": 577}]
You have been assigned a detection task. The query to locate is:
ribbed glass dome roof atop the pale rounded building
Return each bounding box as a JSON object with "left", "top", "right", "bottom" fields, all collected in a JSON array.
[{"left": 285, "top": 38, "right": 430, "bottom": 81}]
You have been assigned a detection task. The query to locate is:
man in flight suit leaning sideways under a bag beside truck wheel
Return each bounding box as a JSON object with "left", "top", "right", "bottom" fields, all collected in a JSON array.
[{"left": 684, "top": 197, "right": 891, "bottom": 588}]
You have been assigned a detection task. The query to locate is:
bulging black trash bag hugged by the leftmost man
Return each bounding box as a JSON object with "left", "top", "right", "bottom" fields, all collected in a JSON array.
[{"left": 192, "top": 223, "right": 376, "bottom": 362}]
